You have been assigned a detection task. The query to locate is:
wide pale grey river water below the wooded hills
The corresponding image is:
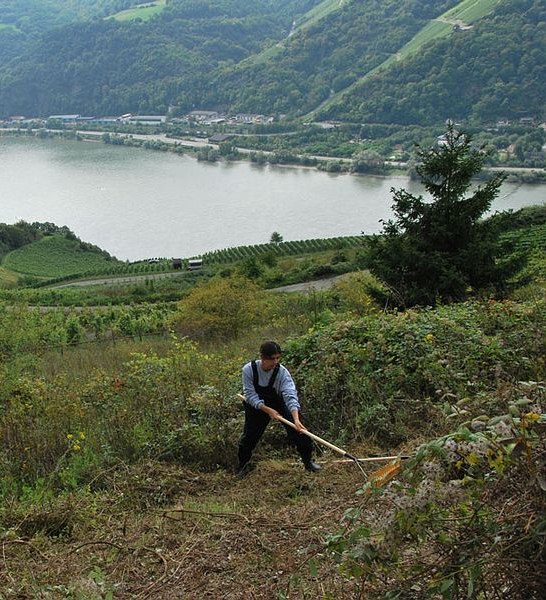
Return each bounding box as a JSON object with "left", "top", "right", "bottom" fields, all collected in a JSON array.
[{"left": 0, "top": 137, "right": 546, "bottom": 261}]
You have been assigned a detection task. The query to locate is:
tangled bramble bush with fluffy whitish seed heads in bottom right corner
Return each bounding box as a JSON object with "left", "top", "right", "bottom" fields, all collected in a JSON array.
[{"left": 325, "top": 382, "right": 546, "bottom": 600}]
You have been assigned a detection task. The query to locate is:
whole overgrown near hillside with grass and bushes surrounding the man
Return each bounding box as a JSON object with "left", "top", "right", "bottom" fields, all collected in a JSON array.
[{"left": 0, "top": 211, "right": 546, "bottom": 600}]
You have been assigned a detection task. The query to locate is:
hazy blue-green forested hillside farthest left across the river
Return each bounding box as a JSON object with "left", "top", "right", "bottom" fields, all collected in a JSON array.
[{"left": 0, "top": 0, "right": 318, "bottom": 115}]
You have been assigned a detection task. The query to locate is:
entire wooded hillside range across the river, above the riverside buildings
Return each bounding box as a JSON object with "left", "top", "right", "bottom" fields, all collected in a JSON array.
[{"left": 0, "top": 0, "right": 546, "bottom": 125}]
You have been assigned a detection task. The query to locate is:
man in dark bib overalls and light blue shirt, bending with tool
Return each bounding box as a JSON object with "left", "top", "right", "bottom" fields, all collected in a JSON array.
[{"left": 237, "top": 342, "right": 320, "bottom": 479}]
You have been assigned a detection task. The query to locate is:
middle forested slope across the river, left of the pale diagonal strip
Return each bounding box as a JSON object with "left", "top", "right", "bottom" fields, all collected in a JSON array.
[{"left": 205, "top": 0, "right": 458, "bottom": 115}]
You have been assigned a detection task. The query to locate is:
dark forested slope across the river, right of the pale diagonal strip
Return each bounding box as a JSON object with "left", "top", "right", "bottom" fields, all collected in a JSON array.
[{"left": 322, "top": 0, "right": 546, "bottom": 124}]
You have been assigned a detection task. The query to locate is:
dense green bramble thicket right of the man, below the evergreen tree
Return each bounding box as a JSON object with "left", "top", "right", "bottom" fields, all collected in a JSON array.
[{"left": 285, "top": 299, "right": 546, "bottom": 446}]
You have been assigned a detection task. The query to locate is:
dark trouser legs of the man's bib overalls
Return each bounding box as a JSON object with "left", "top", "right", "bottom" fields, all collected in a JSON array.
[{"left": 238, "top": 402, "right": 313, "bottom": 467}]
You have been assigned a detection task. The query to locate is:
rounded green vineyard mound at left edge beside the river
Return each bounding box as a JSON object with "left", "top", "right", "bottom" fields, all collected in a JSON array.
[{"left": 3, "top": 235, "right": 121, "bottom": 278}]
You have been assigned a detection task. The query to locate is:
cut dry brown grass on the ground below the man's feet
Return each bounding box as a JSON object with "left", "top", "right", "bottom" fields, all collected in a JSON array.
[{"left": 0, "top": 452, "right": 386, "bottom": 600}]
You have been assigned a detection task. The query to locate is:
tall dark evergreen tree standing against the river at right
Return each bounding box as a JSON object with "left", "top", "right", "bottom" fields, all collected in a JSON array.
[{"left": 368, "top": 125, "right": 519, "bottom": 307}]
